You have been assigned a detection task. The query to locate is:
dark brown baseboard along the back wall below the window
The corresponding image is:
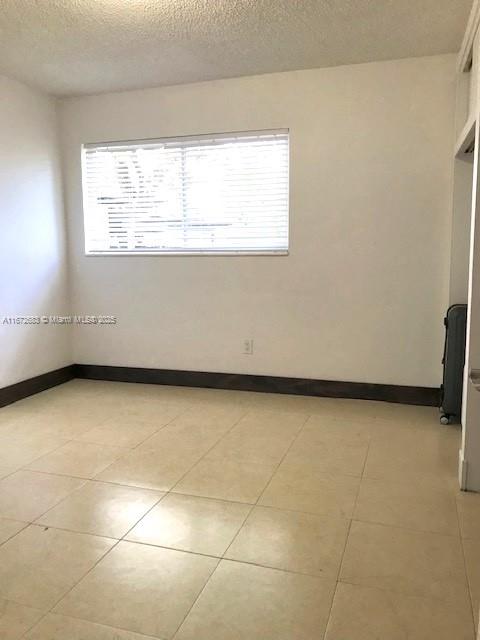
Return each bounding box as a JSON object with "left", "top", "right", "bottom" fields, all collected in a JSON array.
[{"left": 75, "top": 364, "right": 440, "bottom": 407}]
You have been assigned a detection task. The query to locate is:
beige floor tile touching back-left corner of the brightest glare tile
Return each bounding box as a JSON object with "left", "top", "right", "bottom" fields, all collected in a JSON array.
[{"left": 96, "top": 448, "right": 201, "bottom": 491}]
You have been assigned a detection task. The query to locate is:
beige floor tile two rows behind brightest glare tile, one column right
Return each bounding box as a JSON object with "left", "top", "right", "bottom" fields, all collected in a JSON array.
[{"left": 285, "top": 432, "right": 368, "bottom": 477}]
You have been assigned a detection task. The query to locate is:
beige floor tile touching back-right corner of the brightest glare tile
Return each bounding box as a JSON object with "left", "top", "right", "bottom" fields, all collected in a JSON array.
[{"left": 259, "top": 463, "right": 360, "bottom": 519}]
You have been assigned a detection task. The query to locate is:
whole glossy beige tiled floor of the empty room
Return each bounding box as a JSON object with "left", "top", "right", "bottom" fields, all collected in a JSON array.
[{"left": 0, "top": 380, "right": 480, "bottom": 640}]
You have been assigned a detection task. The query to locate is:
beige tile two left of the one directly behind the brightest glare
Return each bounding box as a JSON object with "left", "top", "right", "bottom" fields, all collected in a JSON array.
[{"left": 28, "top": 441, "right": 129, "bottom": 478}]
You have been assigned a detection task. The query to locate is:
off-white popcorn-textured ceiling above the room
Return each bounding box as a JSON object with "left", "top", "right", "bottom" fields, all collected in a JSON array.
[{"left": 0, "top": 0, "right": 471, "bottom": 95}]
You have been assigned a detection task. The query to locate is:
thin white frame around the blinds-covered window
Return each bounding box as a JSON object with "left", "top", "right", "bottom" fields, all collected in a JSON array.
[{"left": 81, "top": 128, "right": 291, "bottom": 258}]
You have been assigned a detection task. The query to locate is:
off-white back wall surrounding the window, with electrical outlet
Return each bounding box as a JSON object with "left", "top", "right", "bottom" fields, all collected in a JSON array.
[{"left": 61, "top": 55, "right": 455, "bottom": 386}]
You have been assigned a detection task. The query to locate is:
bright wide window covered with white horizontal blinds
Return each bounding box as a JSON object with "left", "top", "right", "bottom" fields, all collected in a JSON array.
[{"left": 82, "top": 131, "right": 289, "bottom": 255}]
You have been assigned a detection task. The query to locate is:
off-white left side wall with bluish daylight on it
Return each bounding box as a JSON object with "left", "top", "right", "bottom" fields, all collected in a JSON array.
[{"left": 0, "top": 76, "right": 72, "bottom": 387}]
